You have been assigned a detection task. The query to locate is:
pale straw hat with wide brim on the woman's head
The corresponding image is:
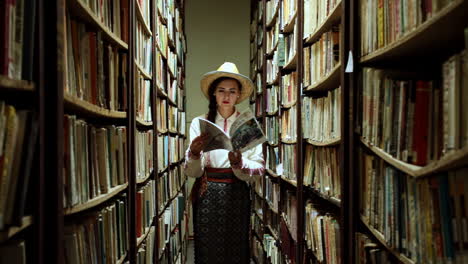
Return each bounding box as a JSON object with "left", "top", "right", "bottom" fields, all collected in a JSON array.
[{"left": 200, "top": 62, "right": 254, "bottom": 104}]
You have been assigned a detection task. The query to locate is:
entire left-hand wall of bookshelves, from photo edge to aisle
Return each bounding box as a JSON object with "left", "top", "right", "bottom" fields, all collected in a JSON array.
[{"left": 0, "top": 0, "right": 188, "bottom": 263}]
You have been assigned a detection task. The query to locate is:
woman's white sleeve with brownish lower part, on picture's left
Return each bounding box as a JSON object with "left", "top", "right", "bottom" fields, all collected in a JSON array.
[{"left": 184, "top": 118, "right": 204, "bottom": 178}]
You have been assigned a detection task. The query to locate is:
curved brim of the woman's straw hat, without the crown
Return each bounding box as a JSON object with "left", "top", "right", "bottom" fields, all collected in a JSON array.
[{"left": 200, "top": 71, "right": 254, "bottom": 104}]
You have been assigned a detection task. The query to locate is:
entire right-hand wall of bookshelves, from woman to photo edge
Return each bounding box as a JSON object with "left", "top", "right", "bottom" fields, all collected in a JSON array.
[{"left": 251, "top": 0, "right": 468, "bottom": 263}]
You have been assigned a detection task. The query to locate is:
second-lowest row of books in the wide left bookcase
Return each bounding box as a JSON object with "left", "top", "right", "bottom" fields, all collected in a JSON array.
[{"left": 63, "top": 115, "right": 128, "bottom": 208}]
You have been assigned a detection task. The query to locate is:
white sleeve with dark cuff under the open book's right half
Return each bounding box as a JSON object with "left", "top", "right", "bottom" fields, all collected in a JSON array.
[{"left": 232, "top": 144, "right": 265, "bottom": 182}]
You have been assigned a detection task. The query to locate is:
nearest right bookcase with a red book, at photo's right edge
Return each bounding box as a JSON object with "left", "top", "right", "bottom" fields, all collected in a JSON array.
[{"left": 351, "top": 0, "right": 468, "bottom": 263}]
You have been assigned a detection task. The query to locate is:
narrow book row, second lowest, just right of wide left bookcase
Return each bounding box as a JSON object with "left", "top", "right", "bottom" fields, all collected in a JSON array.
[{"left": 135, "top": 180, "right": 156, "bottom": 238}]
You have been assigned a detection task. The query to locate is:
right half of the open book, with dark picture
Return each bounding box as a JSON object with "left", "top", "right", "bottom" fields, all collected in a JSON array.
[{"left": 229, "top": 109, "right": 266, "bottom": 152}]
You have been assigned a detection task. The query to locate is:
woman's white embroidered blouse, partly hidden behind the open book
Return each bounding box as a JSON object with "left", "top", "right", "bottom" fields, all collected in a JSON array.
[{"left": 185, "top": 111, "right": 265, "bottom": 181}]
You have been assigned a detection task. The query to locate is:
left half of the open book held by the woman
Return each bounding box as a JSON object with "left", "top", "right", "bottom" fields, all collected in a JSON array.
[{"left": 199, "top": 118, "right": 233, "bottom": 152}]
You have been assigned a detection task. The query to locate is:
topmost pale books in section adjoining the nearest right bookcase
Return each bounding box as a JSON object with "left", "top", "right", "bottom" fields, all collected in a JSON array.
[{"left": 303, "top": 0, "right": 341, "bottom": 39}]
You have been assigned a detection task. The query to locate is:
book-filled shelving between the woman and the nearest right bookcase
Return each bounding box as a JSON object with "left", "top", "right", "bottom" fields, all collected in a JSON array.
[{"left": 251, "top": 0, "right": 352, "bottom": 263}]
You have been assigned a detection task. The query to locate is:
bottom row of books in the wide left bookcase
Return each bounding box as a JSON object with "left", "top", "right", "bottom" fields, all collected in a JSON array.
[{"left": 64, "top": 194, "right": 128, "bottom": 264}]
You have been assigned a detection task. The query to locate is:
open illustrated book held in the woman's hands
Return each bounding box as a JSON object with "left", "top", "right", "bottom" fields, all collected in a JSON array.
[{"left": 199, "top": 109, "right": 266, "bottom": 152}]
